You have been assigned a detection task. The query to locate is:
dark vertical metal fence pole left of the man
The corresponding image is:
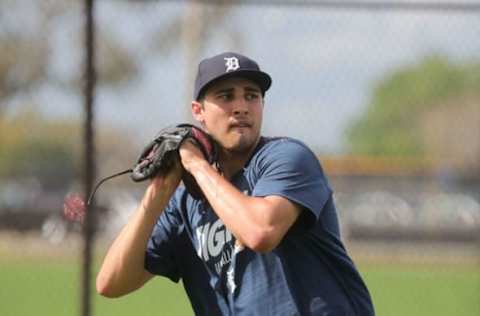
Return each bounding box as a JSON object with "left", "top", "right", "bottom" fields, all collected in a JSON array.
[{"left": 81, "top": 0, "right": 96, "bottom": 316}]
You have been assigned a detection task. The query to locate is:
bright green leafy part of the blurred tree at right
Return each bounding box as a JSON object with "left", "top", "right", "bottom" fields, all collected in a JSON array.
[{"left": 347, "top": 56, "right": 480, "bottom": 156}]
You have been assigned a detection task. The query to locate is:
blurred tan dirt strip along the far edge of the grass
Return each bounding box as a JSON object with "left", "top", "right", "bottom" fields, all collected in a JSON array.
[{"left": 0, "top": 231, "right": 480, "bottom": 265}]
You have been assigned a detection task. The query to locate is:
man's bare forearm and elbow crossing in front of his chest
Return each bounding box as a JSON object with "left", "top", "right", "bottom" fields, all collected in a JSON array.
[{"left": 180, "top": 143, "right": 301, "bottom": 252}]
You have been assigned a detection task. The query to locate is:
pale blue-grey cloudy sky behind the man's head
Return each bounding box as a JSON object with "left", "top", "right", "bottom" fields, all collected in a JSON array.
[{"left": 20, "top": 1, "right": 480, "bottom": 154}]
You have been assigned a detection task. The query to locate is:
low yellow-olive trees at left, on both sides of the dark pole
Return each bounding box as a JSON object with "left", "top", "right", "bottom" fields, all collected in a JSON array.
[{"left": 0, "top": 107, "right": 138, "bottom": 189}]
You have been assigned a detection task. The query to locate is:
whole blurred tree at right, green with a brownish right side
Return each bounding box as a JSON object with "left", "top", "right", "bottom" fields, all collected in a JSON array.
[{"left": 347, "top": 55, "right": 480, "bottom": 162}]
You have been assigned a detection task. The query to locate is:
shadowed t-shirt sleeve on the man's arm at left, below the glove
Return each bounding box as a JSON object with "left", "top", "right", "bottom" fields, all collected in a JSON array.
[{"left": 145, "top": 197, "right": 184, "bottom": 282}]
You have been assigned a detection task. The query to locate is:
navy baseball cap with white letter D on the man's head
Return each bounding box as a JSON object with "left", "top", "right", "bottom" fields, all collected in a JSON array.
[{"left": 193, "top": 52, "right": 272, "bottom": 101}]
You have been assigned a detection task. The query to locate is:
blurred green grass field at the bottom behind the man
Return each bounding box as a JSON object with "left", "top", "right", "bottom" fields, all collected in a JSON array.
[{"left": 0, "top": 241, "right": 480, "bottom": 316}]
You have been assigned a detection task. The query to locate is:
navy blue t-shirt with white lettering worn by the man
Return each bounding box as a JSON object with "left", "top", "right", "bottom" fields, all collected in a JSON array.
[{"left": 145, "top": 137, "right": 374, "bottom": 316}]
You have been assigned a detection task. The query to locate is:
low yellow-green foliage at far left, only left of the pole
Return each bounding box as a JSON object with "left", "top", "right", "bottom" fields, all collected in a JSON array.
[{"left": 0, "top": 111, "right": 79, "bottom": 187}]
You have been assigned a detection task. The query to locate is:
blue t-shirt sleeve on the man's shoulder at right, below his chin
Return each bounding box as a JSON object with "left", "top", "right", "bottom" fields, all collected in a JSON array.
[{"left": 252, "top": 139, "right": 332, "bottom": 227}]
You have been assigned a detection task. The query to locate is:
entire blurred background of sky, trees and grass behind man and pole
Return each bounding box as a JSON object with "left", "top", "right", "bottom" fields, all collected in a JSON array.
[{"left": 0, "top": 0, "right": 480, "bottom": 316}]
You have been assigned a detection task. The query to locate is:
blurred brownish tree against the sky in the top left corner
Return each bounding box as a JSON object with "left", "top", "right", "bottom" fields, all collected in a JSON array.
[{"left": 0, "top": 0, "right": 137, "bottom": 113}]
